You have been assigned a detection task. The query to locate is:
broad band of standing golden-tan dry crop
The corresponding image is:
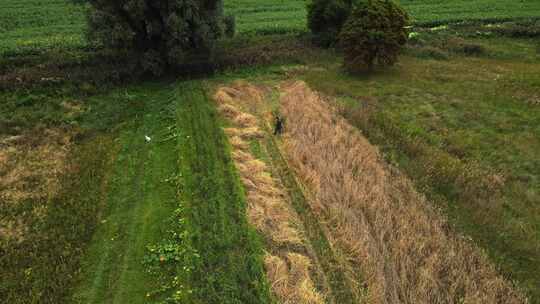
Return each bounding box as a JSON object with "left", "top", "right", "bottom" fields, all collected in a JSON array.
[{"left": 281, "top": 82, "right": 527, "bottom": 303}]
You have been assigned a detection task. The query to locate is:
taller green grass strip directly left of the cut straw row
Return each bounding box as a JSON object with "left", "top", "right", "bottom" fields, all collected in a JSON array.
[{"left": 172, "top": 83, "right": 272, "bottom": 304}]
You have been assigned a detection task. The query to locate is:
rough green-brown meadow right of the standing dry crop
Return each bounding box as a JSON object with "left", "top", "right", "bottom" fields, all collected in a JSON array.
[{"left": 305, "top": 27, "right": 540, "bottom": 303}]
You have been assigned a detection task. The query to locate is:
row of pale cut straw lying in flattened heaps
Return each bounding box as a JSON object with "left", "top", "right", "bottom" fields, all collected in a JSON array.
[{"left": 214, "top": 83, "right": 324, "bottom": 304}]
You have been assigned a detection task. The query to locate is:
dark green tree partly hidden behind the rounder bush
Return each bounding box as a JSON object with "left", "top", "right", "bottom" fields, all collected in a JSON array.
[{"left": 307, "top": 0, "right": 352, "bottom": 46}]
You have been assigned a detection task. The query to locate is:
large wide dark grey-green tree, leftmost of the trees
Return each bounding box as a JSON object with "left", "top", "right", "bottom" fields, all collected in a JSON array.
[{"left": 87, "top": 0, "right": 225, "bottom": 74}]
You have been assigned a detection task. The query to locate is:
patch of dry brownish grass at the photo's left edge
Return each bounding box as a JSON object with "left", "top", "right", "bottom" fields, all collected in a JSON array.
[{"left": 0, "top": 129, "right": 73, "bottom": 242}]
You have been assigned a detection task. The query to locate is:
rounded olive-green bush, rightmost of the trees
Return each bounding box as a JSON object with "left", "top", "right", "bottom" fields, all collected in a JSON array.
[{"left": 339, "top": 0, "right": 409, "bottom": 71}]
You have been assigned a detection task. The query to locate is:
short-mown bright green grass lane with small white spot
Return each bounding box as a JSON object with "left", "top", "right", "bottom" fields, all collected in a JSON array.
[{"left": 73, "top": 85, "right": 177, "bottom": 303}]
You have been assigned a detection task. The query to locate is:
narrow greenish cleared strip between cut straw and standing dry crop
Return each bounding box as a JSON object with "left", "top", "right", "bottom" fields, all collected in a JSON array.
[{"left": 265, "top": 129, "right": 359, "bottom": 304}]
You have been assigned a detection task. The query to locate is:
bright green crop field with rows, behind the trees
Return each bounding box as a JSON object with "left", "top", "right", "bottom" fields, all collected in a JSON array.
[{"left": 0, "top": 0, "right": 540, "bottom": 55}]
